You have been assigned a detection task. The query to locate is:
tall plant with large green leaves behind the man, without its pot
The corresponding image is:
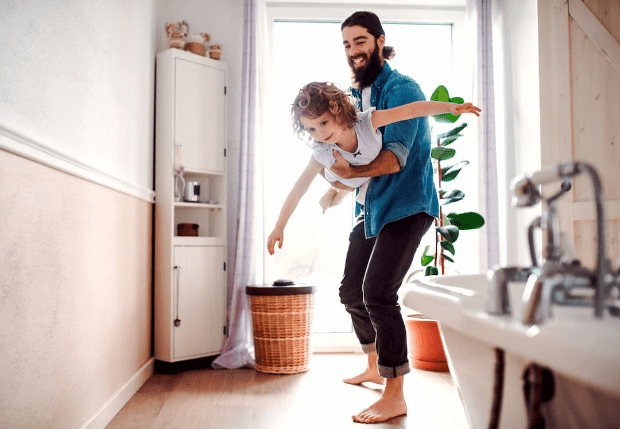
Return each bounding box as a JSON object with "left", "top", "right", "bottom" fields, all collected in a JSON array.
[{"left": 421, "top": 85, "right": 484, "bottom": 276}]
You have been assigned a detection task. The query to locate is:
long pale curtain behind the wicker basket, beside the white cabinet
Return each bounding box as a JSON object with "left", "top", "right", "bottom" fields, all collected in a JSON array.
[{"left": 213, "top": 0, "right": 264, "bottom": 368}]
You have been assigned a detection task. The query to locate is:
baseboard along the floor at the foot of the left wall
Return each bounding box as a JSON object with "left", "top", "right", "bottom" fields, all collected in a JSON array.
[{"left": 79, "top": 358, "right": 155, "bottom": 429}]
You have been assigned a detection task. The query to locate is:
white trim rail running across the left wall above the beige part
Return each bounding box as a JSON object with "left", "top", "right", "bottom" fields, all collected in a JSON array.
[{"left": 0, "top": 125, "right": 155, "bottom": 203}]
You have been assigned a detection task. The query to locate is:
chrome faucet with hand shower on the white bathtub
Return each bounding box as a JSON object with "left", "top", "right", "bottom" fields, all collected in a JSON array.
[{"left": 487, "top": 162, "right": 620, "bottom": 325}]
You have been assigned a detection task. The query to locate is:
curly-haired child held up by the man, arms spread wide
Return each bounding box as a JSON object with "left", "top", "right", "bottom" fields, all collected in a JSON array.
[{"left": 267, "top": 82, "right": 480, "bottom": 255}]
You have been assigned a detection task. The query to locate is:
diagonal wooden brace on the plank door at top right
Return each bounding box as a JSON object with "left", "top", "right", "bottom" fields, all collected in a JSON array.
[{"left": 568, "top": 0, "right": 620, "bottom": 73}]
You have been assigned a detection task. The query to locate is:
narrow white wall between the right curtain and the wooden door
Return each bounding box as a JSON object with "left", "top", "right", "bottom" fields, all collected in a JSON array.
[{"left": 492, "top": 0, "right": 541, "bottom": 265}]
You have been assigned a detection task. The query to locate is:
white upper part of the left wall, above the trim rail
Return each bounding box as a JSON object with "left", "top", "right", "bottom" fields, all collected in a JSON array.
[{"left": 0, "top": 0, "right": 154, "bottom": 189}]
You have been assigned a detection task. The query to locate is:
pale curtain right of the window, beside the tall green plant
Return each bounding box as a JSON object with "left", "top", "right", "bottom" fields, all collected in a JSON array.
[{"left": 467, "top": 0, "right": 500, "bottom": 269}]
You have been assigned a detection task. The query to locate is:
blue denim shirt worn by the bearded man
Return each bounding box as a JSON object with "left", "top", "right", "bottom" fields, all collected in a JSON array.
[{"left": 351, "top": 62, "right": 439, "bottom": 238}]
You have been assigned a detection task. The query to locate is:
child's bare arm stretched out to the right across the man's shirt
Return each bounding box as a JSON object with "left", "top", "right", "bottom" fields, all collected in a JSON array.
[{"left": 371, "top": 101, "right": 480, "bottom": 130}]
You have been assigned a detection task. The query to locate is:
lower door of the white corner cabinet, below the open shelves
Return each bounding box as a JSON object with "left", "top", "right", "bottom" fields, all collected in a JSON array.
[{"left": 171, "top": 246, "right": 226, "bottom": 360}]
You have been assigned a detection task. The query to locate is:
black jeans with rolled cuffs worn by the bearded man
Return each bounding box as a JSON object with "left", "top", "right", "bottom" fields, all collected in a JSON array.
[{"left": 340, "top": 213, "right": 434, "bottom": 378}]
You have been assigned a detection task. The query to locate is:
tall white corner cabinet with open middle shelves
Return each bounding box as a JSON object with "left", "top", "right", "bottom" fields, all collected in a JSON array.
[{"left": 155, "top": 49, "right": 227, "bottom": 362}]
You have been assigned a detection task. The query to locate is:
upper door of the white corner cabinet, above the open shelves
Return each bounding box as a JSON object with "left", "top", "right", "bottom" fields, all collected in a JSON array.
[{"left": 175, "top": 58, "right": 226, "bottom": 172}]
